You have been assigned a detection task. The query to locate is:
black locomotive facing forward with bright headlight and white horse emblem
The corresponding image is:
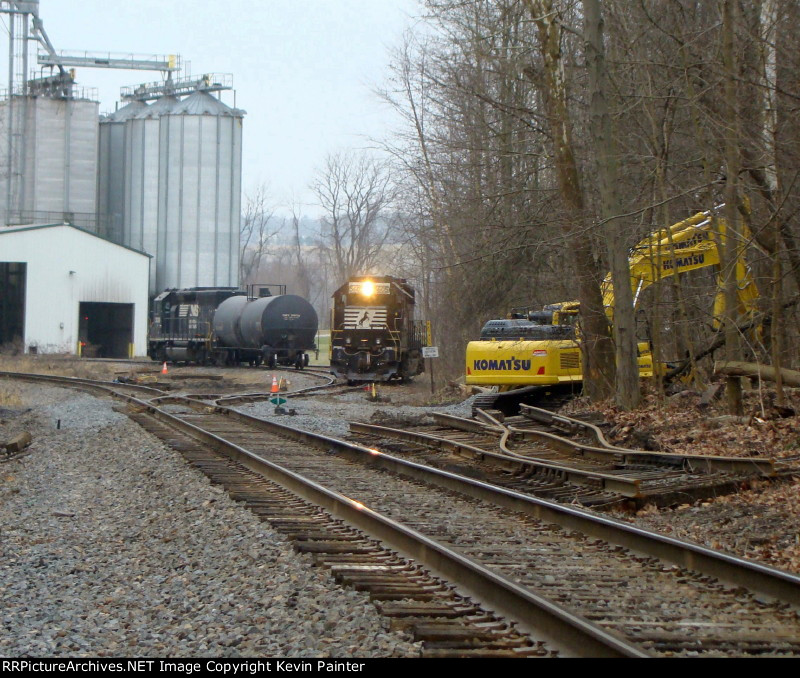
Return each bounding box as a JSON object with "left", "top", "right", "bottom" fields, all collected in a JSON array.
[{"left": 331, "top": 276, "right": 426, "bottom": 383}]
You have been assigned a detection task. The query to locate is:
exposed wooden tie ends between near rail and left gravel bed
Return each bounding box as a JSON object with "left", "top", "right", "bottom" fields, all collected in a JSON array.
[{"left": 132, "top": 413, "right": 553, "bottom": 657}]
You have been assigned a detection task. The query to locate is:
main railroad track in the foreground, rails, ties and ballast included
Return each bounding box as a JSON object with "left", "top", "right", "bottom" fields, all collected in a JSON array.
[{"left": 4, "top": 372, "right": 800, "bottom": 656}]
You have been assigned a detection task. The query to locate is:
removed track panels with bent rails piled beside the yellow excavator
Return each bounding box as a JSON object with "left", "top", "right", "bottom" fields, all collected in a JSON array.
[{"left": 350, "top": 406, "right": 776, "bottom": 508}]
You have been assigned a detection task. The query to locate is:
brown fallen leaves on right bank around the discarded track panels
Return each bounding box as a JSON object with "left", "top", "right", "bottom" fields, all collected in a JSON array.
[{"left": 564, "top": 389, "right": 800, "bottom": 573}]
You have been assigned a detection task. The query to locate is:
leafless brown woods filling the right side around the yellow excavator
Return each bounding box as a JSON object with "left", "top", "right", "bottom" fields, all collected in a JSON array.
[{"left": 381, "top": 0, "right": 800, "bottom": 397}]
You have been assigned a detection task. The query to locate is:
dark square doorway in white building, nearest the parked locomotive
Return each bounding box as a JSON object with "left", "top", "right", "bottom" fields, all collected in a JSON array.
[{"left": 78, "top": 301, "right": 133, "bottom": 358}]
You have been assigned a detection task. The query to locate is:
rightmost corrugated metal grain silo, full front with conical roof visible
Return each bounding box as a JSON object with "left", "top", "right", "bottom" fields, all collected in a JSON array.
[{"left": 158, "top": 90, "right": 243, "bottom": 289}]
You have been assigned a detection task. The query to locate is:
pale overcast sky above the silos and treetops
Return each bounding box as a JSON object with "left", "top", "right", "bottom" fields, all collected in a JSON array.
[{"left": 0, "top": 0, "right": 420, "bottom": 214}]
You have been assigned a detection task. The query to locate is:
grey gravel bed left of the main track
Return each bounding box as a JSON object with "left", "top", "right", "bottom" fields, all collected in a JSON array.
[{"left": 0, "top": 384, "right": 419, "bottom": 657}]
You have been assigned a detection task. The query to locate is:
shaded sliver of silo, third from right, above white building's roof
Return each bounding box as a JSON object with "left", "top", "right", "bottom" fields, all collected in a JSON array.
[{"left": 97, "top": 101, "right": 147, "bottom": 244}]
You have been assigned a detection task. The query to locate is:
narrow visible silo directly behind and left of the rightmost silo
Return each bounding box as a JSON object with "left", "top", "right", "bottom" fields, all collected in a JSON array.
[{"left": 122, "top": 96, "right": 179, "bottom": 294}]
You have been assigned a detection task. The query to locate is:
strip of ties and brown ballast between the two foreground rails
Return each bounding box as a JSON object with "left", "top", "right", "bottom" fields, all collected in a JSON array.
[{"left": 141, "top": 402, "right": 800, "bottom": 655}]
